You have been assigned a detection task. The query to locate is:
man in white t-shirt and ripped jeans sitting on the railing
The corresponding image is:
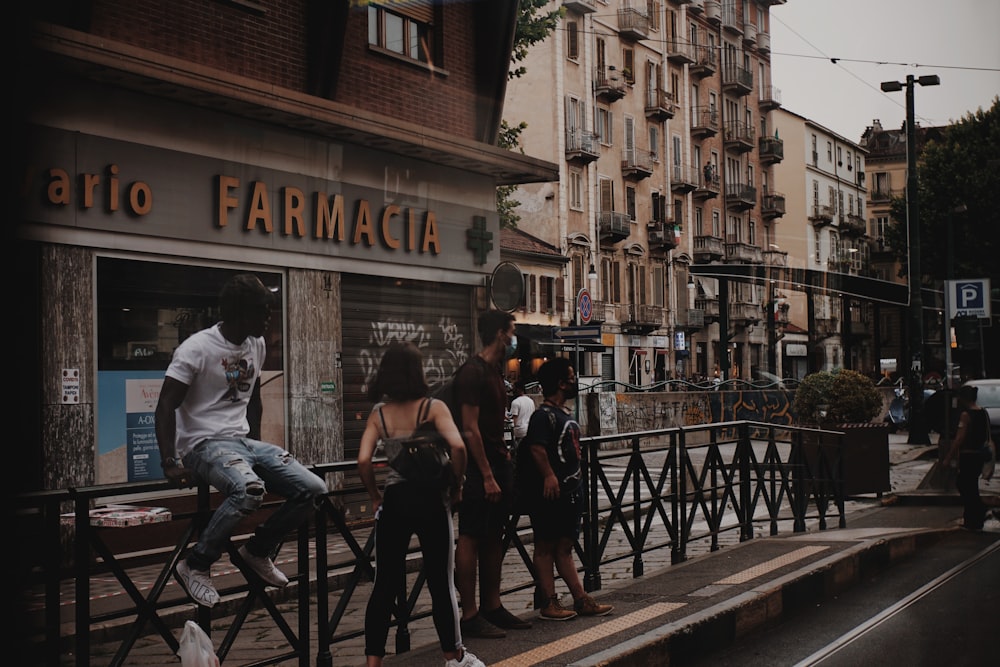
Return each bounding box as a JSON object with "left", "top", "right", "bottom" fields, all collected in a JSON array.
[{"left": 156, "top": 273, "right": 327, "bottom": 607}]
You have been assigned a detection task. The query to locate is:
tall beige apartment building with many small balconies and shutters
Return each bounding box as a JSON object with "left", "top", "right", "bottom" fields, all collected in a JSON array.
[{"left": 504, "top": 0, "right": 784, "bottom": 387}]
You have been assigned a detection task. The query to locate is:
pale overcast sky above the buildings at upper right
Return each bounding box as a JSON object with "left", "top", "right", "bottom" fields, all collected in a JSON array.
[{"left": 771, "top": 0, "right": 1000, "bottom": 142}]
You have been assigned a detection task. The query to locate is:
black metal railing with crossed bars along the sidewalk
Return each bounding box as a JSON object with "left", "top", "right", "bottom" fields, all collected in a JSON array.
[{"left": 16, "top": 421, "right": 846, "bottom": 667}]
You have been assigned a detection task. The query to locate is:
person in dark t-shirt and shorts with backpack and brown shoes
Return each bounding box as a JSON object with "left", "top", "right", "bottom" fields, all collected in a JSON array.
[{"left": 517, "top": 357, "right": 614, "bottom": 621}]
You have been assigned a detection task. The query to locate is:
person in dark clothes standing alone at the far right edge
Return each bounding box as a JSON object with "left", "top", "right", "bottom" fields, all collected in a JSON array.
[{"left": 942, "top": 385, "right": 990, "bottom": 530}]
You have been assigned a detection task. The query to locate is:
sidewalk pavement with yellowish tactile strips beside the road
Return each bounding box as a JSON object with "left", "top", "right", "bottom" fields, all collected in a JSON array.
[{"left": 60, "top": 433, "right": 1000, "bottom": 667}]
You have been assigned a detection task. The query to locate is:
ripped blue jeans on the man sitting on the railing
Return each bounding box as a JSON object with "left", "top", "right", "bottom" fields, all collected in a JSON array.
[{"left": 183, "top": 438, "right": 327, "bottom": 570}]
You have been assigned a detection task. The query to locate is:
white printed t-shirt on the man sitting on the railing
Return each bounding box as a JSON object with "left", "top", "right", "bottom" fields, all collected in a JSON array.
[{"left": 167, "top": 325, "right": 265, "bottom": 457}]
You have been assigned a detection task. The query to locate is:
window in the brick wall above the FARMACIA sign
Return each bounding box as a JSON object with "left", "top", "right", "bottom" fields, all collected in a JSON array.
[{"left": 368, "top": 0, "right": 437, "bottom": 64}]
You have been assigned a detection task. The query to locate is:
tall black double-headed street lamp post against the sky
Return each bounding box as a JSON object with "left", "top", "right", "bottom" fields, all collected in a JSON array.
[{"left": 881, "top": 74, "right": 941, "bottom": 444}]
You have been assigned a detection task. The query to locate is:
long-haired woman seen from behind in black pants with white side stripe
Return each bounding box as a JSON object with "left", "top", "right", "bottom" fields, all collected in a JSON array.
[{"left": 358, "top": 343, "right": 484, "bottom": 667}]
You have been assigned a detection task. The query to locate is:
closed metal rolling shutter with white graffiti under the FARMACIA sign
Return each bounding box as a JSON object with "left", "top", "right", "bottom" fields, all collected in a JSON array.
[{"left": 341, "top": 274, "right": 479, "bottom": 461}]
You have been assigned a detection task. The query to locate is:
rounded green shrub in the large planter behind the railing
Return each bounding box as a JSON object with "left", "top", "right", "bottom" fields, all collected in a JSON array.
[{"left": 792, "top": 369, "right": 882, "bottom": 424}]
